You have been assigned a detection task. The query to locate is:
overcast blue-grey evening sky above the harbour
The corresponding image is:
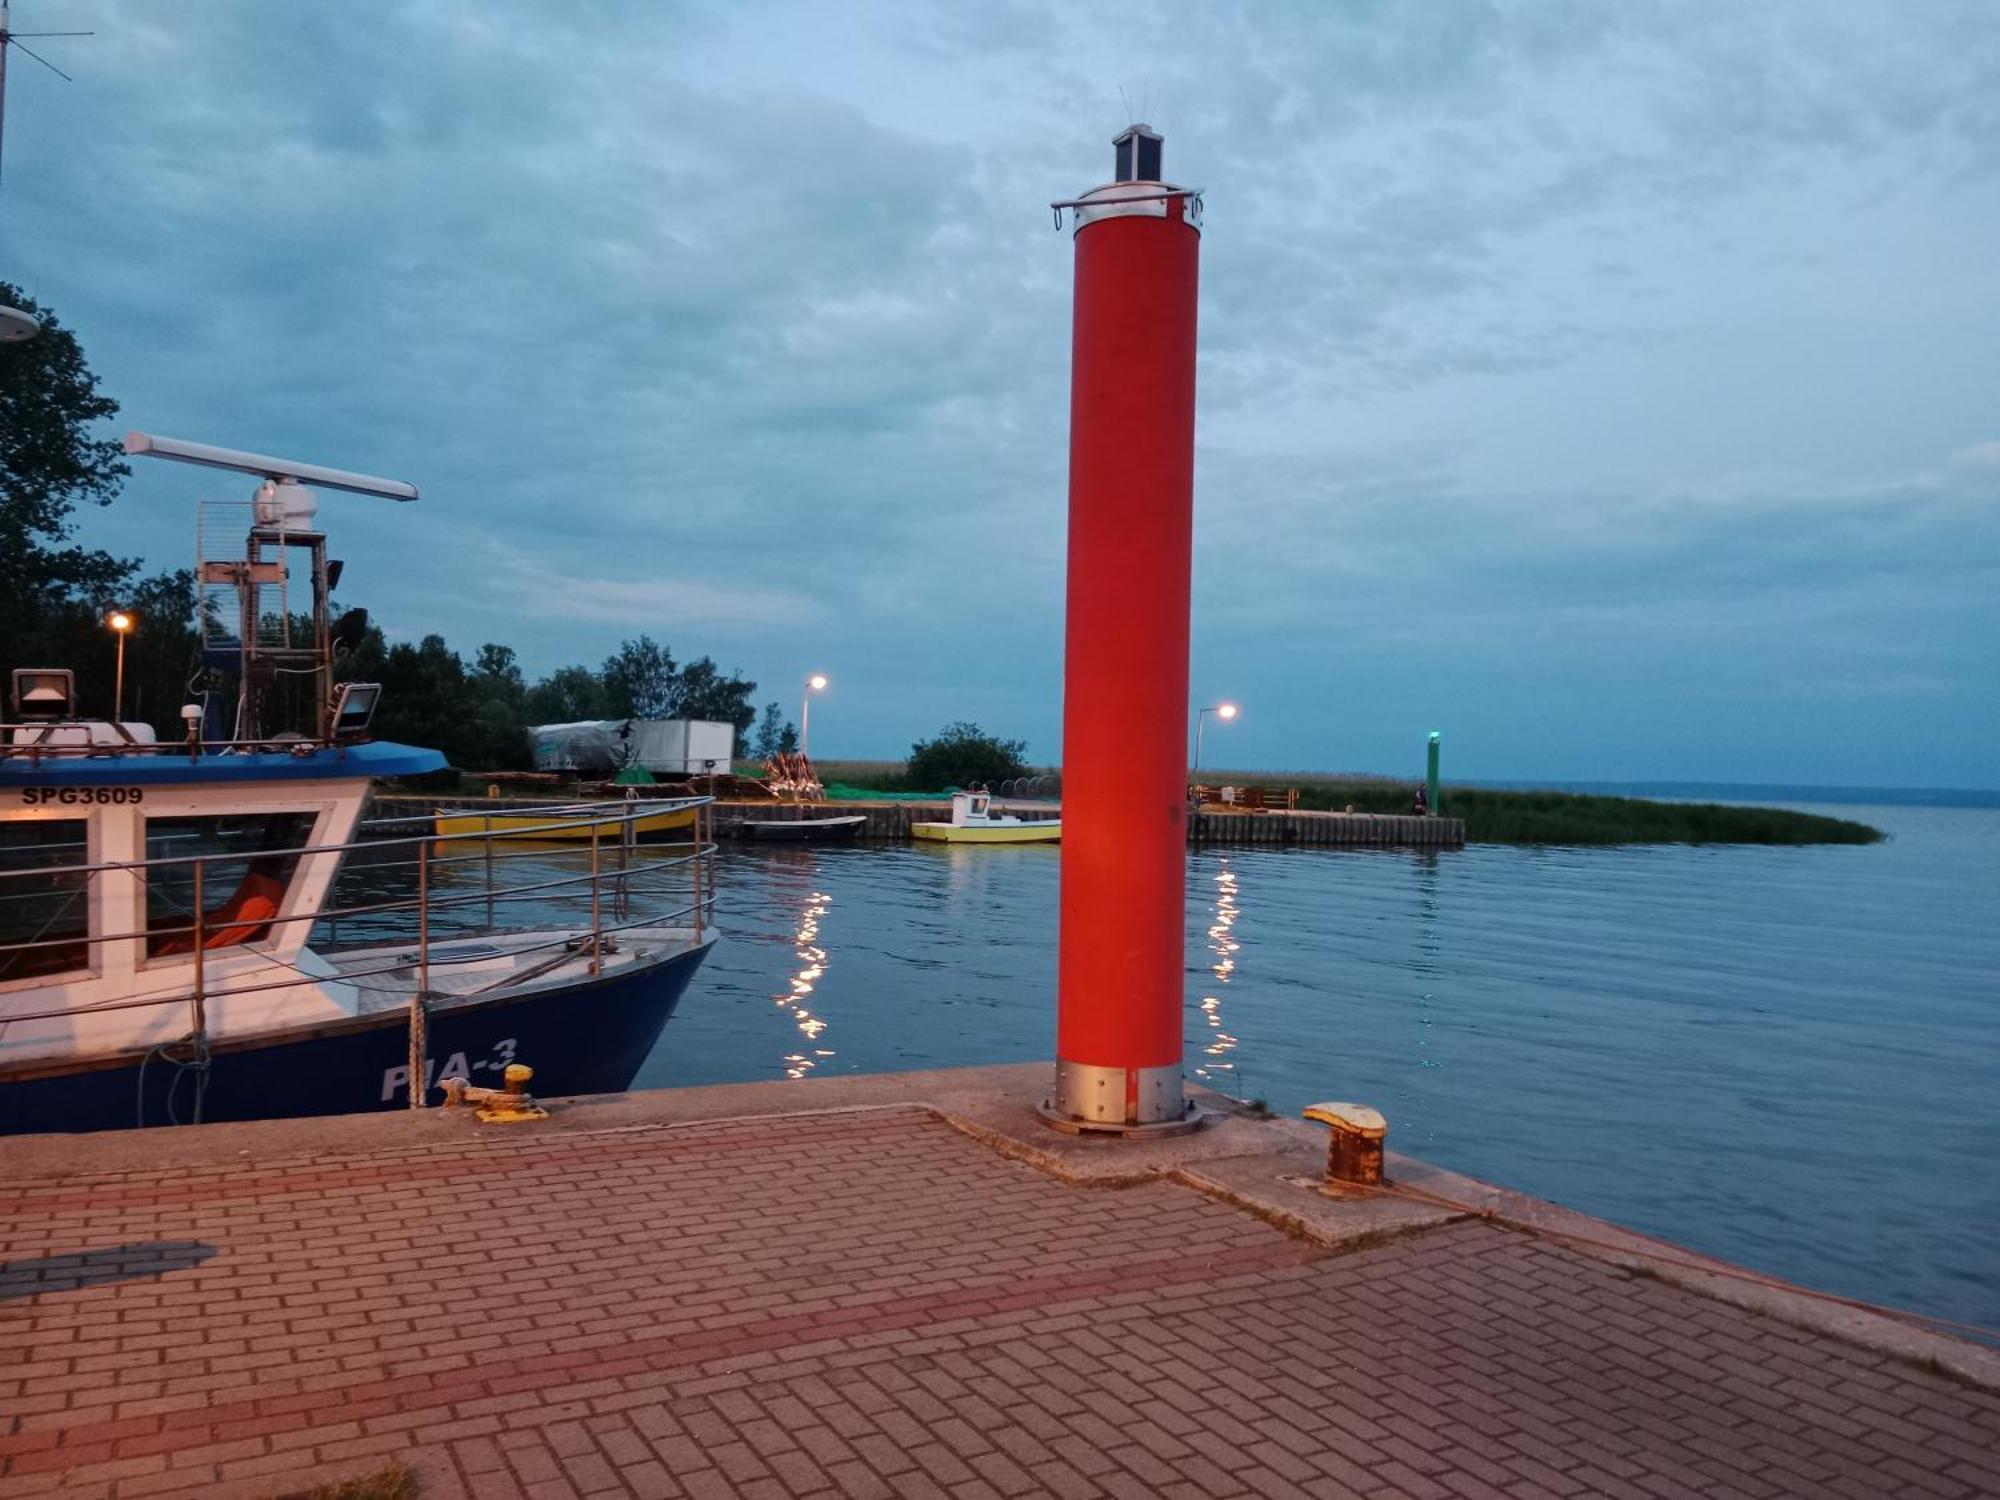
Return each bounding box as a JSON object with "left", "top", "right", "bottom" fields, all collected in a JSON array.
[{"left": 0, "top": 0, "right": 2000, "bottom": 786}]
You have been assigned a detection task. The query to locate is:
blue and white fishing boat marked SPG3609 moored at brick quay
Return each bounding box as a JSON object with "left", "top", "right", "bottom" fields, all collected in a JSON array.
[{"left": 0, "top": 434, "right": 714, "bottom": 1134}]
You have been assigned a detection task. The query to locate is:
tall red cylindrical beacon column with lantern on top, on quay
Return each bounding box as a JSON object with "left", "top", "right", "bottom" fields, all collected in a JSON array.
[{"left": 1050, "top": 124, "right": 1202, "bottom": 1130}]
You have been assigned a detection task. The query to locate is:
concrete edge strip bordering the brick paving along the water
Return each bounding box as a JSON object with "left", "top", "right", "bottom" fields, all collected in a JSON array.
[{"left": 11, "top": 1062, "right": 2000, "bottom": 1392}]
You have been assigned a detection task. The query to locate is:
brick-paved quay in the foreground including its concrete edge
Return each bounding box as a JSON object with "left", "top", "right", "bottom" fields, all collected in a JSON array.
[{"left": 0, "top": 1066, "right": 2000, "bottom": 1500}]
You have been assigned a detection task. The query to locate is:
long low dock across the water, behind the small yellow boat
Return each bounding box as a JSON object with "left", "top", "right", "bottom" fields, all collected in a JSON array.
[{"left": 370, "top": 796, "right": 1466, "bottom": 848}]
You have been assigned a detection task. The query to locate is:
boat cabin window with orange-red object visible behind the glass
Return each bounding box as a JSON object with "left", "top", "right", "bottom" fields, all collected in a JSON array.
[{"left": 146, "top": 812, "right": 312, "bottom": 958}]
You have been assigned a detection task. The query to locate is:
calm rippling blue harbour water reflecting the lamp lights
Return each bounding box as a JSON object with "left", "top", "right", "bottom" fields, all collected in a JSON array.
[{"left": 638, "top": 808, "right": 2000, "bottom": 1326}]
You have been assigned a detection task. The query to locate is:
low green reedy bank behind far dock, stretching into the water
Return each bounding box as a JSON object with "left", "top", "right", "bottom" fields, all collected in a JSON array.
[{"left": 804, "top": 760, "right": 1882, "bottom": 844}]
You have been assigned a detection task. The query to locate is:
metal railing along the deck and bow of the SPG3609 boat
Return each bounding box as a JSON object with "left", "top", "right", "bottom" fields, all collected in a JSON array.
[{"left": 0, "top": 798, "right": 716, "bottom": 1048}]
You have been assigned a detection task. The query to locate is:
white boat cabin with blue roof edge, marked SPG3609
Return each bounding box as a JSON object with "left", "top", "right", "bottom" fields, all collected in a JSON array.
[{"left": 0, "top": 704, "right": 442, "bottom": 1066}]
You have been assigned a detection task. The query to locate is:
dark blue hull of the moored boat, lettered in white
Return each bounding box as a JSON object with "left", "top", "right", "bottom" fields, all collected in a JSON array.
[{"left": 0, "top": 944, "right": 708, "bottom": 1134}]
